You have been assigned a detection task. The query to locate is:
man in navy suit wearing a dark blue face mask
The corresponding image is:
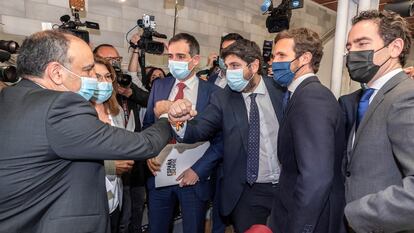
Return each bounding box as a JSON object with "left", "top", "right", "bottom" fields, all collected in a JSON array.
[{"left": 272, "top": 28, "right": 345, "bottom": 233}]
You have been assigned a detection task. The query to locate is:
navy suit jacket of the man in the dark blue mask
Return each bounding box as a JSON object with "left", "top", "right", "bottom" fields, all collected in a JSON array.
[{"left": 274, "top": 76, "right": 345, "bottom": 233}]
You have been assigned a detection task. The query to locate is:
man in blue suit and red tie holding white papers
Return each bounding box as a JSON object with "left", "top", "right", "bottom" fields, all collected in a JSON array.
[{"left": 144, "top": 33, "right": 222, "bottom": 233}]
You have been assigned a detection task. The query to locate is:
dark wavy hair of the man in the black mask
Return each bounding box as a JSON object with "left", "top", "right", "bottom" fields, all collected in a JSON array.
[{"left": 352, "top": 10, "right": 411, "bottom": 66}]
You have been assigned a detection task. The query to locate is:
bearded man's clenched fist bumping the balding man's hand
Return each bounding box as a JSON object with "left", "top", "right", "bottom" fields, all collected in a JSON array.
[{"left": 168, "top": 99, "right": 197, "bottom": 123}]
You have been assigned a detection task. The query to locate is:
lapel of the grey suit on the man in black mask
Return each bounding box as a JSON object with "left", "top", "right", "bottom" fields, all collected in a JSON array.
[{"left": 353, "top": 72, "right": 404, "bottom": 148}]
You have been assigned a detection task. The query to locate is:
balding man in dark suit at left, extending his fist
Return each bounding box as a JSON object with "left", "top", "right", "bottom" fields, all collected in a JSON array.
[{"left": 0, "top": 31, "right": 171, "bottom": 233}]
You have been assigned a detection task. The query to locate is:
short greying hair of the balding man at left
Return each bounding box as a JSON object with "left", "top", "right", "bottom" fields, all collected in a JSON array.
[{"left": 16, "top": 30, "right": 72, "bottom": 78}]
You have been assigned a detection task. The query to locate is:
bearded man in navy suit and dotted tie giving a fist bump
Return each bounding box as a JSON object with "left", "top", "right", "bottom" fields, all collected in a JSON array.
[{"left": 169, "top": 39, "right": 283, "bottom": 233}]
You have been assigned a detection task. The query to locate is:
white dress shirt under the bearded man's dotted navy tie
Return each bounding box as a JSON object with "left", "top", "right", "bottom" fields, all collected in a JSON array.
[{"left": 242, "top": 78, "right": 280, "bottom": 183}]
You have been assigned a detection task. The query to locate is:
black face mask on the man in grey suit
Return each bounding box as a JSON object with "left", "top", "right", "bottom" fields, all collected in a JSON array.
[{"left": 346, "top": 45, "right": 391, "bottom": 83}]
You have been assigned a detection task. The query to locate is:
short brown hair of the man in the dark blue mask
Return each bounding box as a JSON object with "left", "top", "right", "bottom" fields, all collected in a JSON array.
[{"left": 275, "top": 28, "right": 323, "bottom": 73}]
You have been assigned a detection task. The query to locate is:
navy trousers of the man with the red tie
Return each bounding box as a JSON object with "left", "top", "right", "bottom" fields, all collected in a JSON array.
[{"left": 148, "top": 185, "right": 207, "bottom": 233}]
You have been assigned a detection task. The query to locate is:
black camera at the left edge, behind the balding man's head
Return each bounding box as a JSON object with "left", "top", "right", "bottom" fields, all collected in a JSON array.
[{"left": 0, "top": 40, "right": 19, "bottom": 83}]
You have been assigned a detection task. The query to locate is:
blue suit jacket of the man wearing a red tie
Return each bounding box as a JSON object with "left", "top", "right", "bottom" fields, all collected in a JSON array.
[{"left": 143, "top": 76, "right": 223, "bottom": 200}]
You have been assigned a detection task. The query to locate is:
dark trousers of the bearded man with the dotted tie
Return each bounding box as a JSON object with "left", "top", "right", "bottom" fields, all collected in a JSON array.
[{"left": 230, "top": 183, "right": 279, "bottom": 233}]
